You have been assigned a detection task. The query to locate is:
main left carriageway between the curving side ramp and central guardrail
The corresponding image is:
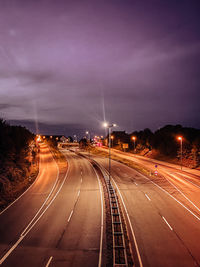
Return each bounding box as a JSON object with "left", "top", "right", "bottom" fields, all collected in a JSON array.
[{"left": 0, "top": 152, "right": 105, "bottom": 266}]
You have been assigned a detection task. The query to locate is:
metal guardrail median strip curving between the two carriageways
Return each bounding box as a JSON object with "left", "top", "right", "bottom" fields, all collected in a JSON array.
[{"left": 77, "top": 153, "right": 134, "bottom": 266}]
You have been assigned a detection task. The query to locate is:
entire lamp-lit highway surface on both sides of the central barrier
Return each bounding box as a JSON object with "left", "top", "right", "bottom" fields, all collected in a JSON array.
[{"left": 0, "top": 144, "right": 200, "bottom": 267}]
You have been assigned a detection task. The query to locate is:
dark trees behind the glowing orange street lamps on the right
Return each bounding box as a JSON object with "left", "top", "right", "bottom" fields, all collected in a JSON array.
[{"left": 112, "top": 125, "right": 200, "bottom": 166}]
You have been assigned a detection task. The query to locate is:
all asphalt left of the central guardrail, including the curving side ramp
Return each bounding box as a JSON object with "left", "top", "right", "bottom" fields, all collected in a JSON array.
[{"left": 0, "top": 144, "right": 106, "bottom": 267}]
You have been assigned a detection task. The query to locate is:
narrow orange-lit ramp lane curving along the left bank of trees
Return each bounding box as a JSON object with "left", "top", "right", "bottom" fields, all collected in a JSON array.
[{"left": 0, "top": 145, "right": 58, "bottom": 255}]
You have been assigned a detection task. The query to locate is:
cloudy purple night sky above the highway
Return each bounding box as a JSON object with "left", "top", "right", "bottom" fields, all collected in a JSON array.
[{"left": 0, "top": 0, "right": 200, "bottom": 135}]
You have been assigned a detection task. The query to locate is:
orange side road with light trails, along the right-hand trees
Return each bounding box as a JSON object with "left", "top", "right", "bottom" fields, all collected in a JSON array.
[{"left": 97, "top": 148, "right": 200, "bottom": 220}]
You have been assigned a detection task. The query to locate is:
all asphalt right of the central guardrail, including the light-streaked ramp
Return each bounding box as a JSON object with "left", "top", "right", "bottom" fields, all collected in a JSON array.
[{"left": 85, "top": 151, "right": 200, "bottom": 267}]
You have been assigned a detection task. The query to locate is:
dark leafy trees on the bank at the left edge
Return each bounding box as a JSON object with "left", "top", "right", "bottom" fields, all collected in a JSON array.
[{"left": 0, "top": 119, "right": 36, "bottom": 209}]
